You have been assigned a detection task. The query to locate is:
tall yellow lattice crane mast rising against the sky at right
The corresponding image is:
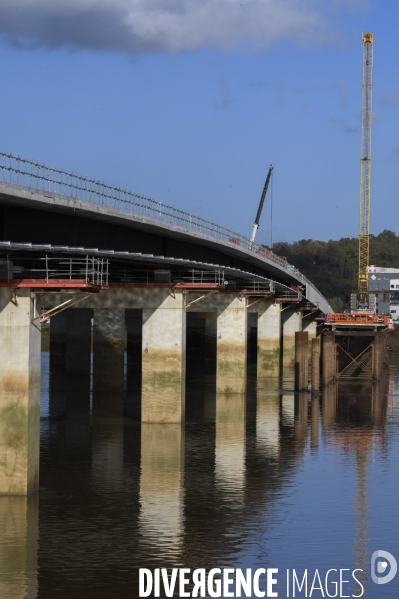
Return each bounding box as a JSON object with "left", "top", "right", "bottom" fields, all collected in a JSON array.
[{"left": 358, "top": 31, "right": 373, "bottom": 306}]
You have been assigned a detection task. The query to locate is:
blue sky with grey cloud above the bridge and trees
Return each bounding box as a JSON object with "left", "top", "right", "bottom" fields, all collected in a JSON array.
[{"left": 0, "top": 0, "right": 399, "bottom": 243}]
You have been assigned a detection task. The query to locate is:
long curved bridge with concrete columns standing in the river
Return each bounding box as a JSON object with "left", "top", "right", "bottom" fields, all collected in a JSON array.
[{"left": 0, "top": 153, "right": 332, "bottom": 494}]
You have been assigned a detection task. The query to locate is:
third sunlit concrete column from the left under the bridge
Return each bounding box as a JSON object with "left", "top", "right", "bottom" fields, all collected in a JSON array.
[{"left": 216, "top": 294, "right": 247, "bottom": 393}]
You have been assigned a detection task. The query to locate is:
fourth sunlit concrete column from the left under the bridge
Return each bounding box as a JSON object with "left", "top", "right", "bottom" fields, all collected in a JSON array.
[{"left": 257, "top": 301, "right": 281, "bottom": 379}]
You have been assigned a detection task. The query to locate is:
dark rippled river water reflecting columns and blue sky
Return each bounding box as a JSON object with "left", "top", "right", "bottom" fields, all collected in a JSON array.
[{"left": 0, "top": 352, "right": 399, "bottom": 599}]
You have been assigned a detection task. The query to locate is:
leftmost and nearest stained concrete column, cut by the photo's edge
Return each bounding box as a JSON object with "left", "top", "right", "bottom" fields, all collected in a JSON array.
[{"left": 0, "top": 288, "right": 41, "bottom": 495}]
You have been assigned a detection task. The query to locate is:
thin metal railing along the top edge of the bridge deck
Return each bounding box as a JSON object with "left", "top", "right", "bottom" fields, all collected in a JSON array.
[{"left": 0, "top": 153, "right": 332, "bottom": 310}]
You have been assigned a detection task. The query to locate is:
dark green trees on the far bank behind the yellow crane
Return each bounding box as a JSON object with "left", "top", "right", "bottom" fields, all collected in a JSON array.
[{"left": 273, "top": 230, "right": 399, "bottom": 304}]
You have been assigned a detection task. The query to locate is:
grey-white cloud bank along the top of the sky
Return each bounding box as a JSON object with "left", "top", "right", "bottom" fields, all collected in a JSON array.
[{"left": 0, "top": 0, "right": 370, "bottom": 53}]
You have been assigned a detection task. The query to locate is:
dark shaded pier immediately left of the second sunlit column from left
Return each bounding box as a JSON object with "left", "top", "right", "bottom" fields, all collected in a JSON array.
[{"left": 93, "top": 308, "right": 125, "bottom": 415}]
